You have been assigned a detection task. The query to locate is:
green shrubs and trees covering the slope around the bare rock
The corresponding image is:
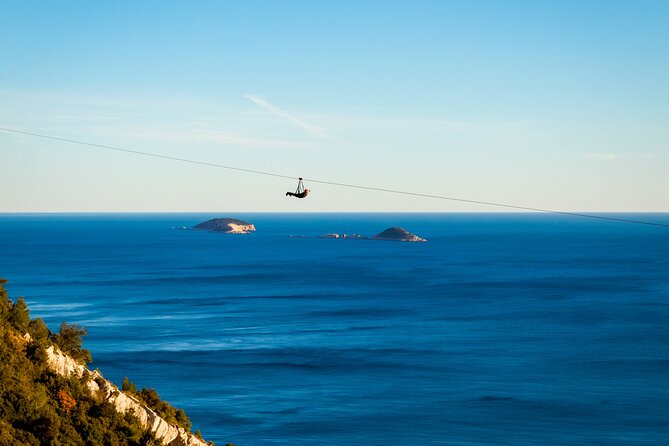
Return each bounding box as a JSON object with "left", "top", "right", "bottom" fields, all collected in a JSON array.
[{"left": 0, "top": 279, "right": 209, "bottom": 446}]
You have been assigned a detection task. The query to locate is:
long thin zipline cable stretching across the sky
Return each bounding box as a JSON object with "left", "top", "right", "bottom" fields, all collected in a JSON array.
[{"left": 0, "top": 127, "right": 669, "bottom": 228}]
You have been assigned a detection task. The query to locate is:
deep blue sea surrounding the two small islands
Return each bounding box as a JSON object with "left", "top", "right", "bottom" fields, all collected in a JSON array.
[{"left": 0, "top": 213, "right": 669, "bottom": 446}]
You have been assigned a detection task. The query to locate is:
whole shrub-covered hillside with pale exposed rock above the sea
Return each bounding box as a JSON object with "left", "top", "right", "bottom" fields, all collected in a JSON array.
[{"left": 0, "top": 279, "right": 212, "bottom": 446}]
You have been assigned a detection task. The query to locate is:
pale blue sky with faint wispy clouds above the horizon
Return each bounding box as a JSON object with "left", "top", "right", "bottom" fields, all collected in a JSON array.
[{"left": 0, "top": 0, "right": 669, "bottom": 212}]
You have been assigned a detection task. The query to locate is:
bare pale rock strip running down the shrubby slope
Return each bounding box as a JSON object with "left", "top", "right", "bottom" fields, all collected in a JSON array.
[{"left": 46, "top": 346, "right": 207, "bottom": 446}]
